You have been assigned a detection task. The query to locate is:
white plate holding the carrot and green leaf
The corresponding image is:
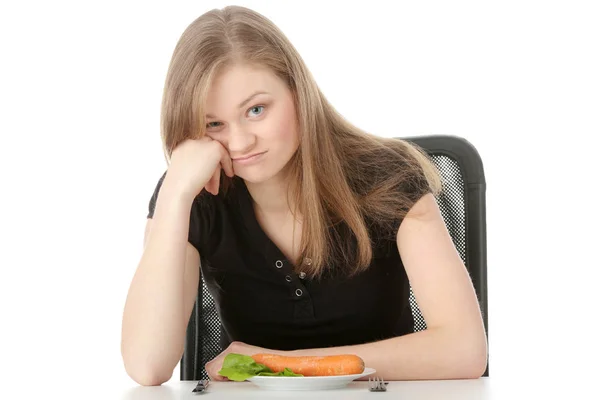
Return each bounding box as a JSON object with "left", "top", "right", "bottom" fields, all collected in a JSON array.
[{"left": 247, "top": 368, "right": 375, "bottom": 390}]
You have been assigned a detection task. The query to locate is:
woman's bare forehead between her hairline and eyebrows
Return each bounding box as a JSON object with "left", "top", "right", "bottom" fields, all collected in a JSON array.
[{"left": 206, "top": 64, "right": 287, "bottom": 114}]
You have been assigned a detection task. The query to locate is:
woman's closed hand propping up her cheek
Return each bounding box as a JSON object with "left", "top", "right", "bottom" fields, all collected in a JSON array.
[{"left": 165, "top": 136, "right": 234, "bottom": 197}]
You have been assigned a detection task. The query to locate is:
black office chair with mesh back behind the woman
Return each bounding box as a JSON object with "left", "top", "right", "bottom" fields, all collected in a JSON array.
[{"left": 180, "top": 135, "right": 489, "bottom": 380}]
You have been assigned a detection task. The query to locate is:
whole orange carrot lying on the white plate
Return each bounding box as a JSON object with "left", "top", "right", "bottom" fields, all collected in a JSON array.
[{"left": 252, "top": 353, "right": 365, "bottom": 376}]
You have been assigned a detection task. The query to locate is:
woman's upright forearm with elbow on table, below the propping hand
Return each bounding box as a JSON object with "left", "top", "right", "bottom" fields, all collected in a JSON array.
[{"left": 121, "top": 180, "right": 196, "bottom": 384}]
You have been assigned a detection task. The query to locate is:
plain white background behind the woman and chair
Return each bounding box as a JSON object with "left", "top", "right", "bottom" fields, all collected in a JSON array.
[{"left": 0, "top": 1, "right": 600, "bottom": 396}]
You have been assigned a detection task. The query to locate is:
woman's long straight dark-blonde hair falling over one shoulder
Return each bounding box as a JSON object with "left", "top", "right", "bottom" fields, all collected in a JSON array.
[{"left": 161, "top": 6, "right": 440, "bottom": 277}]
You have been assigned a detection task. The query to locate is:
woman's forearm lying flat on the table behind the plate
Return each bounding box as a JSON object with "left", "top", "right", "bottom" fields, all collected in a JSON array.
[{"left": 290, "top": 328, "right": 487, "bottom": 380}]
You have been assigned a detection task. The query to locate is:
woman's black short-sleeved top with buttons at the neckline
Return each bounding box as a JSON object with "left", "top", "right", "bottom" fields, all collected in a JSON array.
[{"left": 148, "top": 175, "right": 414, "bottom": 350}]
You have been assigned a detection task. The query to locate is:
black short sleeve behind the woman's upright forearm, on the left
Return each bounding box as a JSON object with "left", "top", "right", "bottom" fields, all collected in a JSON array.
[{"left": 147, "top": 172, "right": 216, "bottom": 256}]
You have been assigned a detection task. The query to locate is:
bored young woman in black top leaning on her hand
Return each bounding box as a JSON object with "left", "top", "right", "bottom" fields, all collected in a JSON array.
[{"left": 121, "top": 7, "right": 487, "bottom": 385}]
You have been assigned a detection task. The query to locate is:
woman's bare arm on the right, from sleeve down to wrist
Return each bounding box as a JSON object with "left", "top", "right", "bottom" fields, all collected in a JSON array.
[{"left": 288, "top": 194, "right": 487, "bottom": 380}]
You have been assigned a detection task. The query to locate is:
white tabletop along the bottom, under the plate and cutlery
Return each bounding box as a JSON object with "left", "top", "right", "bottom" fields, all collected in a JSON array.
[{"left": 12, "top": 374, "right": 600, "bottom": 400}]
